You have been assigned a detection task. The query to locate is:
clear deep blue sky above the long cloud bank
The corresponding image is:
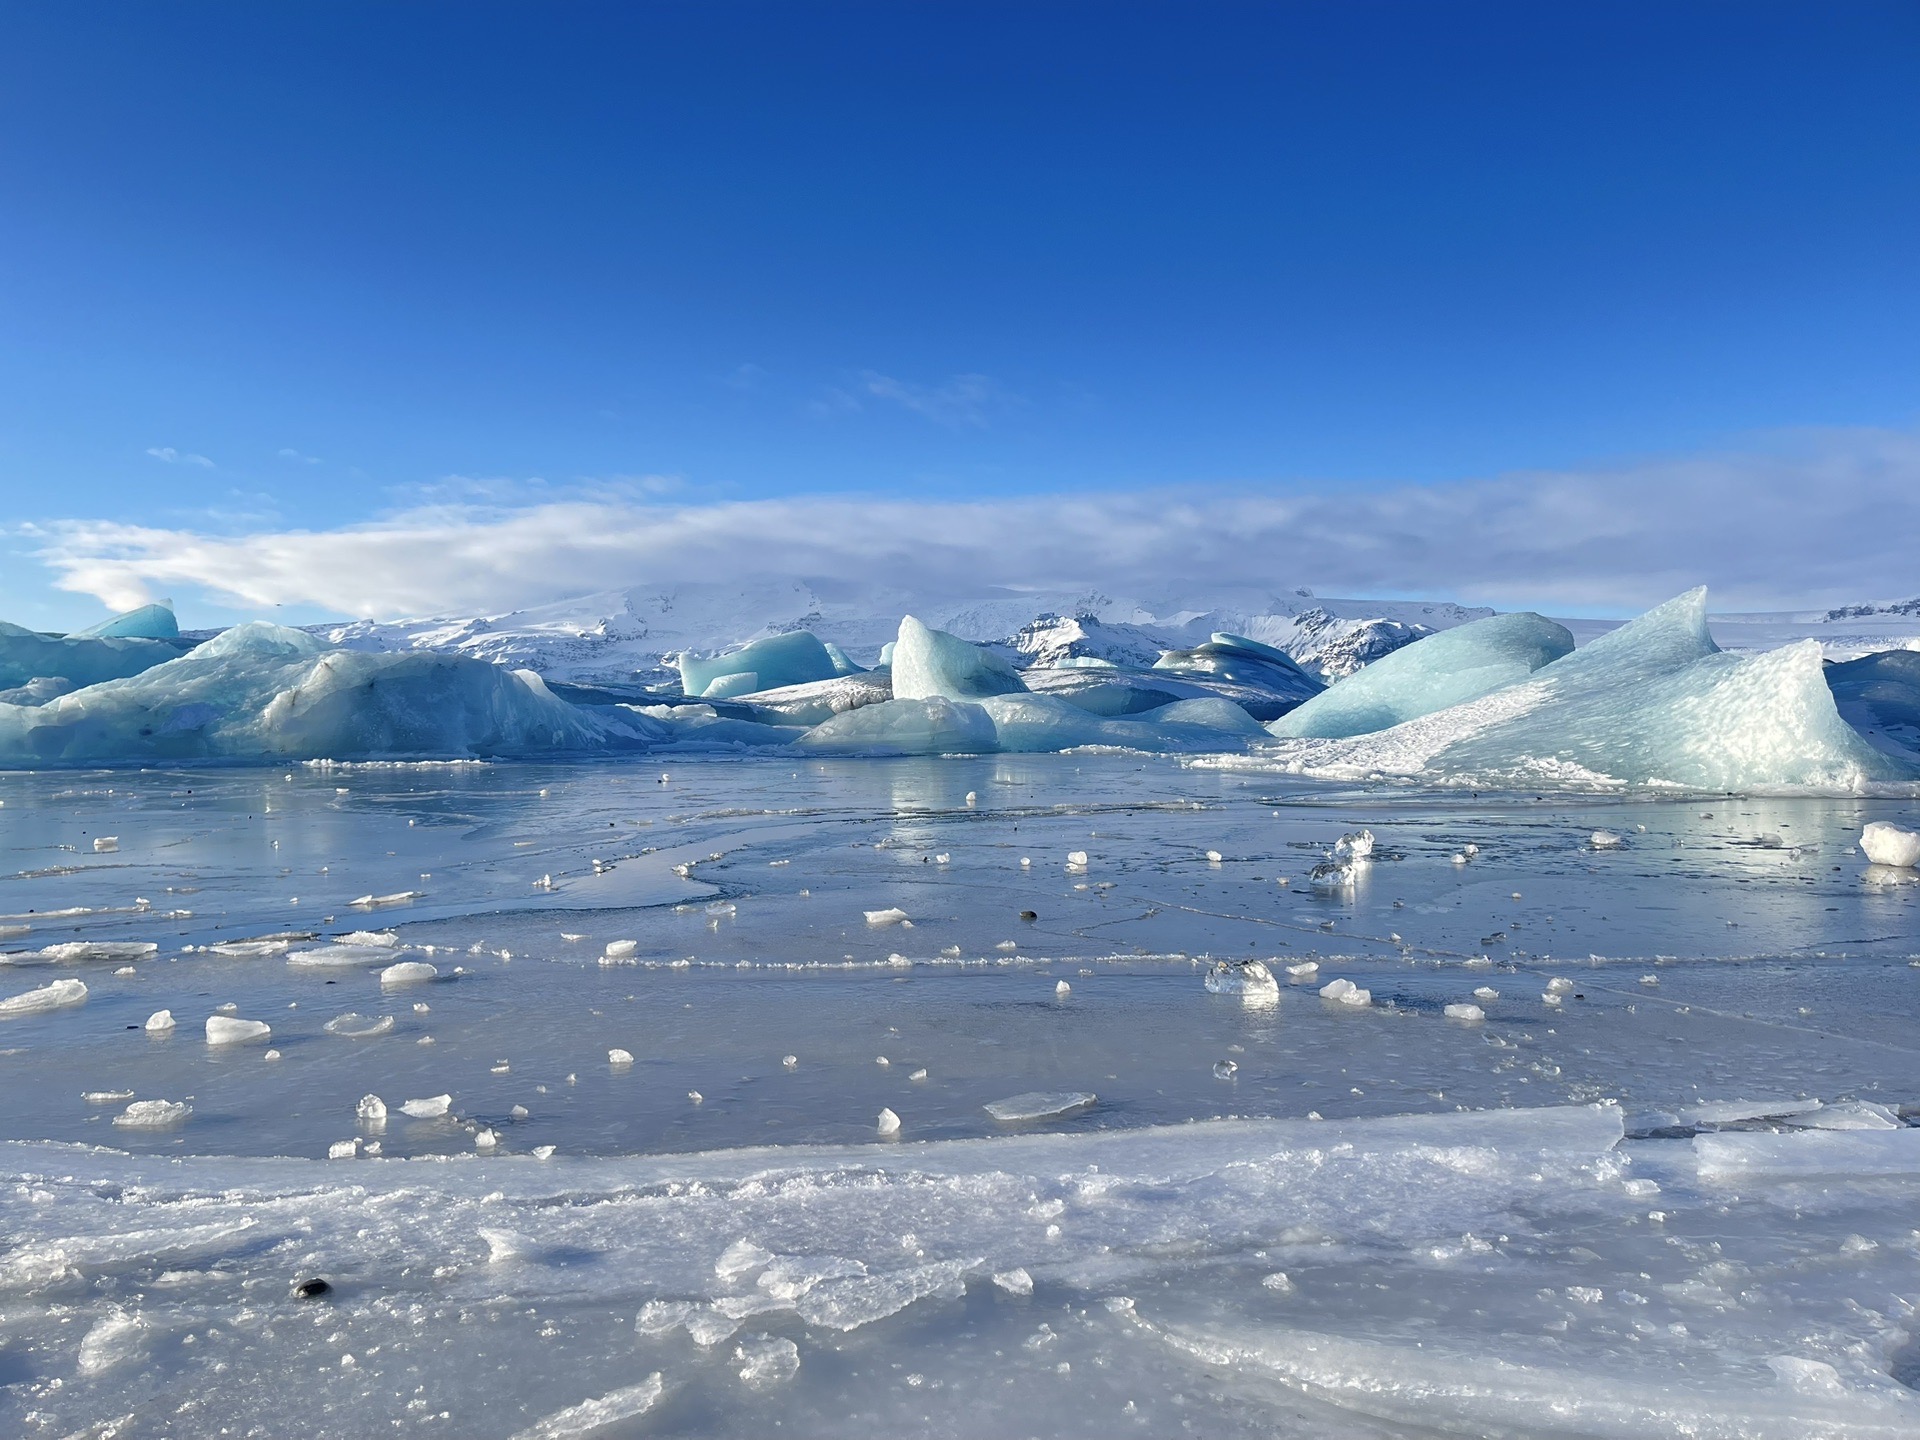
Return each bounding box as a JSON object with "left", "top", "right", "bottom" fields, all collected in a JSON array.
[{"left": 0, "top": 0, "right": 1920, "bottom": 624}]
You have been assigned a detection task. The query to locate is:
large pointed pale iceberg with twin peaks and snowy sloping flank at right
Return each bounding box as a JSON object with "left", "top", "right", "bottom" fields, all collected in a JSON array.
[{"left": 1221, "top": 589, "right": 1920, "bottom": 793}]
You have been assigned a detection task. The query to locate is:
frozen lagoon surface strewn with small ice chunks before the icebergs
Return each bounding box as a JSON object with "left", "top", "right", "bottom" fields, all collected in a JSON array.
[{"left": 0, "top": 755, "right": 1920, "bottom": 1440}]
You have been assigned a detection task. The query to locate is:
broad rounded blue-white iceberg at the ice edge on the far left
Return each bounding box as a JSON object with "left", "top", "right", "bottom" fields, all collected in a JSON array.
[{"left": 0, "top": 622, "right": 666, "bottom": 764}]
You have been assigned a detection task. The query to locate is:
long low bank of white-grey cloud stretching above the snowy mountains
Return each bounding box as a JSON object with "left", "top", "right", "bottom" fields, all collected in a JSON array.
[{"left": 35, "top": 422, "right": 1920, "bottom": 616}]
